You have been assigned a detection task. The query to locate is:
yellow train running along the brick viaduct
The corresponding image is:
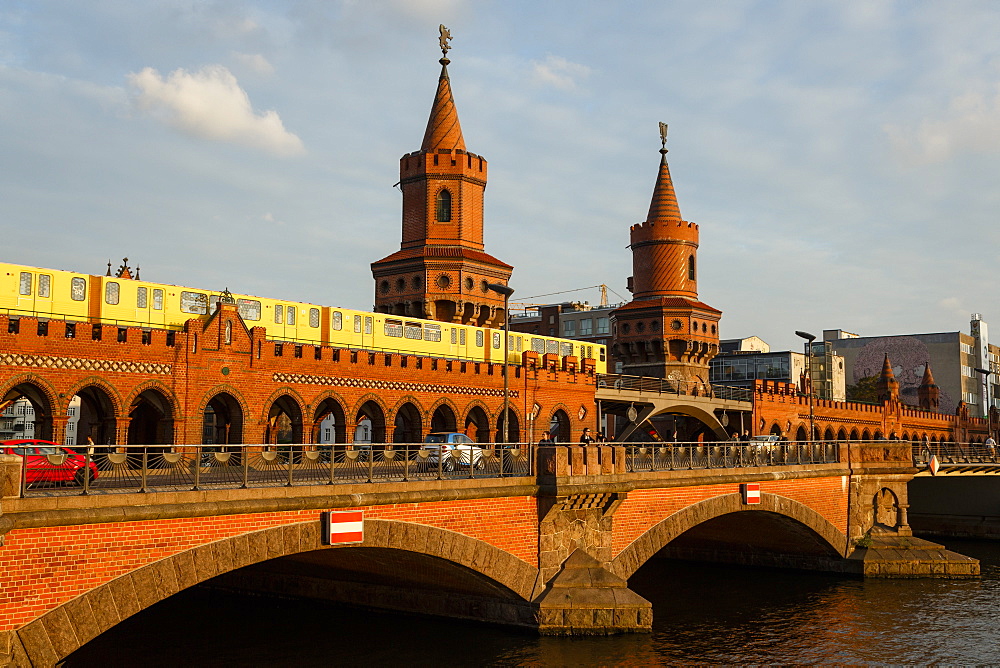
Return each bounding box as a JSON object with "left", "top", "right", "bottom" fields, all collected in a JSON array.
[{"left": 0, "top": 263, "right": 607, "bottom": 373}]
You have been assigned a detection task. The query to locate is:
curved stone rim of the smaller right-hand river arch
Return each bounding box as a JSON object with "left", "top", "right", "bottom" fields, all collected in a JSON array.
[{"left": 610, "top": 494, "right": 847, "bottom": 579}]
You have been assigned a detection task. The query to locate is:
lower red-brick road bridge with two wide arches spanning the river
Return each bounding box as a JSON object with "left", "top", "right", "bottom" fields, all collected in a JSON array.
[{"left": 0, "top": 441, "right": 978, "bottom": 666}]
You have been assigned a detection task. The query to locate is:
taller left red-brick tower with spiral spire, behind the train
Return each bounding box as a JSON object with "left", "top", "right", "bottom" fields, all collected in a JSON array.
[{"left": 371, "top": 31, "right": 513, "bottom": 327}]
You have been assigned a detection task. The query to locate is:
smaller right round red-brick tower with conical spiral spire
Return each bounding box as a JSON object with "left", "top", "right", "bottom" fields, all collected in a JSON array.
[{"left": 612, "top": 128, "right": 722, "bottom": 391}]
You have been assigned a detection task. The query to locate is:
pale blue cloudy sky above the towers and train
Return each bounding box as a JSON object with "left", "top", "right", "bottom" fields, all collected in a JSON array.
[{"left": 0, "top": 0, "right": 1000, "bottom": 350}]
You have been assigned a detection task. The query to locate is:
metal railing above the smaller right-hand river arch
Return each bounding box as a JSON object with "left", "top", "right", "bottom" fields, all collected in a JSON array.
[{"left": 616, "top": 441, "right": 840, "bottom": 473}]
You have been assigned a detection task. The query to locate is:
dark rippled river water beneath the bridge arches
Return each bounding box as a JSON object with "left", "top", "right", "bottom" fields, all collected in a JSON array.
[{"left": 65, "top": 541, "right": 1000, "bottom": 667}]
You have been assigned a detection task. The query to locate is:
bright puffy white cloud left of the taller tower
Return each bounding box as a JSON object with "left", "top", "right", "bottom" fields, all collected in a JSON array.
[{"left": 128, "top": 65, "right": 305, "bottom": 155}]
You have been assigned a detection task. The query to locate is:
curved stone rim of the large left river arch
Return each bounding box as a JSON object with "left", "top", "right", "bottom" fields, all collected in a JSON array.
[{"left": 11, "top": 520, "right": 538, "bottom": 666}]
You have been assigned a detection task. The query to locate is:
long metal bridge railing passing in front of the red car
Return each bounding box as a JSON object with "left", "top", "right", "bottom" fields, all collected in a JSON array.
[{"left": 7, "top": 443, "right": 534, "bottom": 496}]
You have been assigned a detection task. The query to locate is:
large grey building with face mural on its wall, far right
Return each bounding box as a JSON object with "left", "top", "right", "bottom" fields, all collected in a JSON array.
[{"left": 823, "top": 313, "right": 1000, "bottom": 417}]
